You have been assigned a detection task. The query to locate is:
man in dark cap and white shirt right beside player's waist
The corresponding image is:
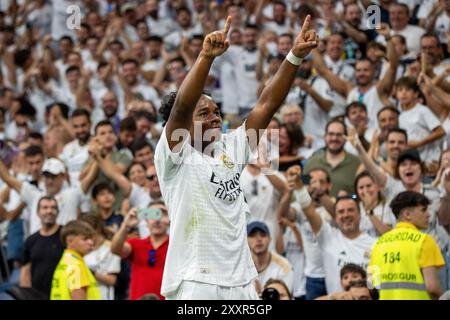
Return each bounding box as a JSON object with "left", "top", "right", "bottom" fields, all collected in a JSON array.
[{"left": 247, "top": 221, "right": 294, "bottom": 295}]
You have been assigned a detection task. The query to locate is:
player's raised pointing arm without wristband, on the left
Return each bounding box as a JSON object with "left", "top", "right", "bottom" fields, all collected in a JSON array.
[{"left": 166, "top": 17, "right": 231, "bottom": 150}]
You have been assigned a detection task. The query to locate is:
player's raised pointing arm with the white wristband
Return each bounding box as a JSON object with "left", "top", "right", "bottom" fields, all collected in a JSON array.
[{"left": 246, "top": 15, "right": 319, "bottom": 147}]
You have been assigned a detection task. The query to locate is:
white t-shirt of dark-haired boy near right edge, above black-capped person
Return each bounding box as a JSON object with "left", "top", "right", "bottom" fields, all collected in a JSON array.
[{"left": 398, "top": 103, "right": 442, "bottom": 163}]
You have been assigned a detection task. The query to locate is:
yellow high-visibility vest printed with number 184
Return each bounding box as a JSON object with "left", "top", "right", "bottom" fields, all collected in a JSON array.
[{"left": 368, "top": 227, "right": 431, "bottom": 300}]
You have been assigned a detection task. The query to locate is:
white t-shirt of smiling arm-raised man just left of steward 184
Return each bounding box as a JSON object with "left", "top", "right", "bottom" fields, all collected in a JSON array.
[{"left": 317, "top": 223, "right": 376, "bottom": 294}]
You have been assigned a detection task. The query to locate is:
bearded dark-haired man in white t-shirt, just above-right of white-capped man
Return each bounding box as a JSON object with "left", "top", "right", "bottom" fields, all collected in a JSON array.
[{"left": 59, "top": 109, "right": 91, "bottom": 185}]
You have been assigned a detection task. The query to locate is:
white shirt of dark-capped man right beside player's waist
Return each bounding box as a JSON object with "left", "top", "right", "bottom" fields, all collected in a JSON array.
[{"left": 258, "top": 251, "right": 294, "bottom": 294}]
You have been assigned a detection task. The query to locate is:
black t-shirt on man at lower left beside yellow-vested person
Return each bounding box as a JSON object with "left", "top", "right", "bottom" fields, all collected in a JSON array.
[{"left": 22, "top": 226, "right": 64, "bottom": 297}]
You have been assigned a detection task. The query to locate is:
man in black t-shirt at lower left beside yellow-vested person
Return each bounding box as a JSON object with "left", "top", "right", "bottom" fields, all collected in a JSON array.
[{"left": 20, "top": 196, "right": 64, "bottom": 297}]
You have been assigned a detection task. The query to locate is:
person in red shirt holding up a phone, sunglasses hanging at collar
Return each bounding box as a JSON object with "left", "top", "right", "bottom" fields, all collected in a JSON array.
[{"left": 111, "top": 201, "right": 169, "bottom": 300}]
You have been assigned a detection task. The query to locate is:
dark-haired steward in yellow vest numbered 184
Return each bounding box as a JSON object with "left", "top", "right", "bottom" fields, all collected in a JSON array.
[{"left": 368, "top": 191, "right": 445, "bottom": 300}]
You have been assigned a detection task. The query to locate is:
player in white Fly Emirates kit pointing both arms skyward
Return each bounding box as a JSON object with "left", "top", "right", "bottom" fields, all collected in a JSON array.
[{"left": 155, "top": 16, "right": 318, "bottom": 300}]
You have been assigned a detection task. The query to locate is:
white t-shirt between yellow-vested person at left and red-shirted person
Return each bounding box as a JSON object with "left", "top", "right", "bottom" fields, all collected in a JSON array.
[{"left": 83, "top": 241, "right": 120, "bottom": 300}]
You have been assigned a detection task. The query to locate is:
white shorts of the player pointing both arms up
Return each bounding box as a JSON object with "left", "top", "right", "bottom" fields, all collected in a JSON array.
[{"left": 166, "top": 280, "right": 259, "bottom": 300}]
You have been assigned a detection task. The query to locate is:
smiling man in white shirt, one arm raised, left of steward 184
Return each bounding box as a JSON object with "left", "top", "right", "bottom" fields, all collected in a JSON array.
[{"left": 288, "top": 166, "right": 375, "bottom": 294}]
